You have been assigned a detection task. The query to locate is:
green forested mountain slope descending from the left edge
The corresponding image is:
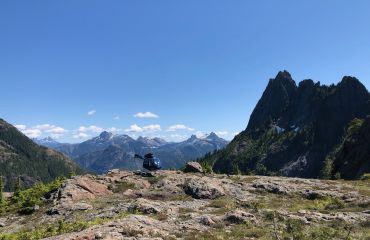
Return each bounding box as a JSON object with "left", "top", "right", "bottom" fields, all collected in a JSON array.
[{"left": 0, "top": 119, "right": 82, "bottom": 191}]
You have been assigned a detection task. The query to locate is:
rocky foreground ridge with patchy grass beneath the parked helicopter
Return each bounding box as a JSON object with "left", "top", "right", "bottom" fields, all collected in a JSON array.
[{"left": 0, "top": 169, "right": 370, "bottom": 240}]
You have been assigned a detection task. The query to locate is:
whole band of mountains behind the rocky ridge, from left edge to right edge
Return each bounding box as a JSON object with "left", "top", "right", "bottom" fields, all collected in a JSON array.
[{"left": 0, "top": 68, "right": 370, "bottom": 190}]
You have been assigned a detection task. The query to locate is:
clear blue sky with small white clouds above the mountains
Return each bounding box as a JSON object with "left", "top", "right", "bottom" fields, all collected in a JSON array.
[{"left": 0, "top": 0, "right": 370, "bottom": 142}]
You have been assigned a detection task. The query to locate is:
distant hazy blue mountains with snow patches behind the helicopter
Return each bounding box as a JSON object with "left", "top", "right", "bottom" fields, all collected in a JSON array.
[{"left": 34, "top": 131, "right": 228, "bottom": 173}]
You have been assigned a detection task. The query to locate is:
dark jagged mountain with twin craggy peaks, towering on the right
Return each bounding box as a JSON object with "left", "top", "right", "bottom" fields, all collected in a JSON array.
[{"left": 200, "top": 71, "right": 370, "bottom": 178}]
